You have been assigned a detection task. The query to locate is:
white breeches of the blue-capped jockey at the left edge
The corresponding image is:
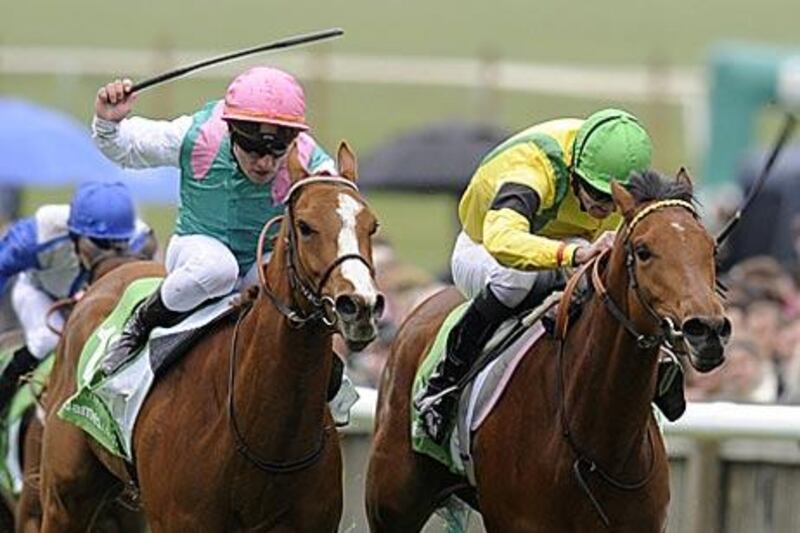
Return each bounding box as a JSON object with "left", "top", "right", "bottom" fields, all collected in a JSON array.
[{"left": 11, "top": 273, "right": 64, "bottom": 361}]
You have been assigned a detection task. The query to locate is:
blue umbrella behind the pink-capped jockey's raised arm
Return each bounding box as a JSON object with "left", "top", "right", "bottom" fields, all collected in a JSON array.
[{"left": 0, "top": 98, "right": 179, "bottom": 204}]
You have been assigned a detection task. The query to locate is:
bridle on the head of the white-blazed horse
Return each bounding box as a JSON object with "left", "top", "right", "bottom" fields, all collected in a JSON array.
[{"left": 256, "top": 176, "right": 375, "bottom": 328}]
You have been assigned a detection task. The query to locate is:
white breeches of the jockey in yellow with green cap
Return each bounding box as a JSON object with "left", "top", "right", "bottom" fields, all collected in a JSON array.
[{"left": 450, "top": 231, "right": 587, "bottom": 308}]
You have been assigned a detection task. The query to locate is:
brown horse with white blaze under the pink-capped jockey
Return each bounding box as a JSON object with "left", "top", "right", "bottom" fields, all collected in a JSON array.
[{"left": 42, "top": 143, "right": 384, "bottom": 533}]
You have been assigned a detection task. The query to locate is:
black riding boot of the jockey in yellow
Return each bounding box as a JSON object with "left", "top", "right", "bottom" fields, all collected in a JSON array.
[{"left": 415, "top": 287, "right": 513, "bottom": 444}]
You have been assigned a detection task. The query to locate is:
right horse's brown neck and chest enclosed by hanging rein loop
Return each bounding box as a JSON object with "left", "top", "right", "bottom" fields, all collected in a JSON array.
[{"left": 564, "top": 250, "right": 658, "bottom": 464}]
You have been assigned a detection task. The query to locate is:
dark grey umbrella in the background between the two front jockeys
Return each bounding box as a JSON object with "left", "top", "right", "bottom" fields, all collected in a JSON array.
[{"left": 359, "top": 122, "right": 510, "bottom": 194}]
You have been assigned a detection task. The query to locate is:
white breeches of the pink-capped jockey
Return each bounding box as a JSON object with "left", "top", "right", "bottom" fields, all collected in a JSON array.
[{"left": 161, "top": 235, "right": 266, "bottom": 312}]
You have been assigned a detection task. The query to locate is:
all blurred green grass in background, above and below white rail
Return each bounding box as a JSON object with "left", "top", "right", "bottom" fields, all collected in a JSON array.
[{"left": 6, "top": 0, "right": 798, "bottom": 271}]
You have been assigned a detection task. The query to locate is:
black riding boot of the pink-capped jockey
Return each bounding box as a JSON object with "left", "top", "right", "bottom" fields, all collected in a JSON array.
[{"left": 103, "top": 285, "right": 191, "bottom": 376}]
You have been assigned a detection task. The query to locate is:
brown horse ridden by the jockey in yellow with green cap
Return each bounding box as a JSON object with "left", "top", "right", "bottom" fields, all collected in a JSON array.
[{"left": 366, "top": 171, "right": 730, "bottom": 533}]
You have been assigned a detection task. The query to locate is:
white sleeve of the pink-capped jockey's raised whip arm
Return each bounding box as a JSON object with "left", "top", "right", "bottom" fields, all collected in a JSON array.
[{"left": 92, "top": 115, "right": 192, "bottom": 168}]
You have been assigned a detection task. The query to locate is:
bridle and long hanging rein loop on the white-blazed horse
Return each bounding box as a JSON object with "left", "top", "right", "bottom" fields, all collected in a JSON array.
[{"left": 228, "top": 176, "right": 374, "bottom": 474}]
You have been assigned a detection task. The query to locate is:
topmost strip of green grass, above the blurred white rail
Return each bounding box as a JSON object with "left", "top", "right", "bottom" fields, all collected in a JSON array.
[{"left": 0, "top": 0, "right": 797, "bottom": 64}]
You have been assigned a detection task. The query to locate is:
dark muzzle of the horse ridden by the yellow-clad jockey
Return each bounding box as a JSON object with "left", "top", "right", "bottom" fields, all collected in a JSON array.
[{"left": 681, "top": 315, "right": 731, "bottom": 373}]
